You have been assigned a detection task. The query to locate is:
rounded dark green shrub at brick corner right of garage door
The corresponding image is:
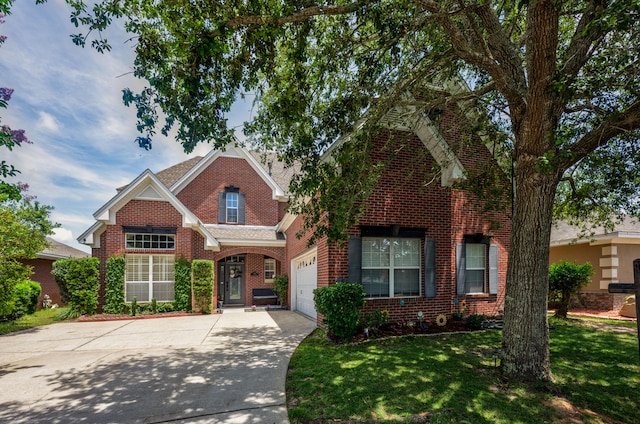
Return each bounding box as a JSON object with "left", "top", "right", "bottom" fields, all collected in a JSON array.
[{"left": 313, "top": 282, "right": 365, "bottom": 342}]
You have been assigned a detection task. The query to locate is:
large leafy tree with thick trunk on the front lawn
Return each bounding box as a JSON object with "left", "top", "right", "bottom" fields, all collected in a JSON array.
[{"left": 69, "top": 0, "right": 640, "bottom": 380}]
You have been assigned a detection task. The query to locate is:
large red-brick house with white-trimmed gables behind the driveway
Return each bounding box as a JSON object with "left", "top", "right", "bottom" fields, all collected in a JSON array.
[{"left": 78, "top": 104, "right": 510, "bottom": 321}]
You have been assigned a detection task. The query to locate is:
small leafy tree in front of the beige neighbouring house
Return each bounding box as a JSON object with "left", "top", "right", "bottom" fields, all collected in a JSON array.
[{"left": 549, "top": 261, "right": 593, "bottom": 318}]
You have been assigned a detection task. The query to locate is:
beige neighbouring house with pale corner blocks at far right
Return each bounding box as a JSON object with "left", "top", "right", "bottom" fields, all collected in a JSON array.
[{"left": 549, "top": 218, "right": 640, "bottom": 311}]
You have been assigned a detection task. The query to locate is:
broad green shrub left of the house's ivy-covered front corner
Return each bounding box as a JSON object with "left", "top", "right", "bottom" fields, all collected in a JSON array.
[{"left": 52, "top": 258, "right": 100, "bottom": 316}]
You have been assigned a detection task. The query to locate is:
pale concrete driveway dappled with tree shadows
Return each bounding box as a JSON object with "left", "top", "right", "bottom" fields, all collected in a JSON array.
[{"left": 0, "top": 310, "right": 315, "bottom": 423}]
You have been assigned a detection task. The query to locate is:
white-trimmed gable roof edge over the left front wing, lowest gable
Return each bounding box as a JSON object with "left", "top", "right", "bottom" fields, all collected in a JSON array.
[{"left": 78, "top": 169, "right": 220, "bottom": 251}]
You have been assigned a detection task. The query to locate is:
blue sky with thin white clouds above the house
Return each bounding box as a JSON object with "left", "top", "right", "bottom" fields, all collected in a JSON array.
[{"left": 0, "top": 0, "right": 251, "bottom": 251}]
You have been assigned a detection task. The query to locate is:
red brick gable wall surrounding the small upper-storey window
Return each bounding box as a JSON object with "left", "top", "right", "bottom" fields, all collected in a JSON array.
[{"left": 177, "top": 157, "right": 281, "bottom": 226}]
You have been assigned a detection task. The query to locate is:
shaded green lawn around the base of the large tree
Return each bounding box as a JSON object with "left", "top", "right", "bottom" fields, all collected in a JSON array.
[{"left": 287, "top": 319, "right": 640, "bottom": 423}]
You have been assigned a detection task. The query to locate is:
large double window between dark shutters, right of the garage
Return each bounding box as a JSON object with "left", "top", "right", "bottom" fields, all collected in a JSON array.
[{"left": 362, "top": 238, "right": 420, "bottom": 297}]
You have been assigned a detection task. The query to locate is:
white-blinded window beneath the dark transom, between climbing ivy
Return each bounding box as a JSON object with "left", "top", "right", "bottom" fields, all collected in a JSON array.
[{"left": 125, "top": 255, "right": 175, "bottom": 302}]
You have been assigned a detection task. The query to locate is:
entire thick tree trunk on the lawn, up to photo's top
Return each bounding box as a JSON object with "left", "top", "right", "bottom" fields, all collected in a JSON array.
[{"left": 502, "top": 0, "right": 562, "bottom": 381}]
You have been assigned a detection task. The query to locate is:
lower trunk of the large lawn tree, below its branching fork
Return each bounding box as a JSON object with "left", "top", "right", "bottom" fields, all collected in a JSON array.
[{"left": 502, "top": 157, "right": 557, "bottom": 381}]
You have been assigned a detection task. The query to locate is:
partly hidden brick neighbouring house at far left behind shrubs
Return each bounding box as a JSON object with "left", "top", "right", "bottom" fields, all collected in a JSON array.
[{"left": 23, "top": 237, "right": 90, "bottom": 308}]
